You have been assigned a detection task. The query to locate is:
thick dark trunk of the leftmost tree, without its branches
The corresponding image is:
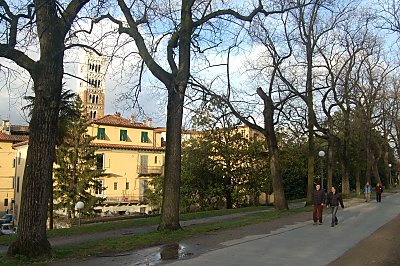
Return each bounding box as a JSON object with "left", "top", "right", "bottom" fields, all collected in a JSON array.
[{"left": 8, "top": 60, "right": 63, "bottom": 258}]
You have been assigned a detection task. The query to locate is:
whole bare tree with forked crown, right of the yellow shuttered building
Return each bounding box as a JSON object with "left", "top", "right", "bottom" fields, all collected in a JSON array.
[{"left": 100, "top": 0, "right": 296, "bottom": 230}]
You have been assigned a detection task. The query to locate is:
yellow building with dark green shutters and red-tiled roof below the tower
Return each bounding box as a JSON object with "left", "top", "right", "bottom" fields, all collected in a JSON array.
[{"left": 88, "top": 113, "right": 164, "bottom": 202}]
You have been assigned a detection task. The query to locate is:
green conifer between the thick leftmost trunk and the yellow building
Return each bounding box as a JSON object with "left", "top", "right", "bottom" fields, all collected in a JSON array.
[{"left": 54, "top": 97, "right": 103, "bottom": 216}]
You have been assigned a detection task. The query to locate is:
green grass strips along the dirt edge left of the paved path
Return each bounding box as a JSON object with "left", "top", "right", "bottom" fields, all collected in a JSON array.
[{"left": 0, "top": 206, "right": 311, "bottom": 265}]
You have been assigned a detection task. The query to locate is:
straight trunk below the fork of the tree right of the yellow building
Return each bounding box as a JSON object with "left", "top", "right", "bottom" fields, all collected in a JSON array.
[{"left": 158, "top": 85, "right": 184, "bottom": 231}]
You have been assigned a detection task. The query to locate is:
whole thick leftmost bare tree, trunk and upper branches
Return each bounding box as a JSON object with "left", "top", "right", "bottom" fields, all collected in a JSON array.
[{"left": 0, "top": 0, "right": 89, "bottom": 258}]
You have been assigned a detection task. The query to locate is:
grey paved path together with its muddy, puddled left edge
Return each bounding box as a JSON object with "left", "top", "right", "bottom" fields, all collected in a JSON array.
[{"left": 55, "top": 193, "right": 400, "bottom": 266}]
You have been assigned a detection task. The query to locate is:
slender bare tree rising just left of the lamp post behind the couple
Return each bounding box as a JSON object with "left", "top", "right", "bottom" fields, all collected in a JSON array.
[{"left": 292, "top": 0, "right": 353, "bottom": 203}]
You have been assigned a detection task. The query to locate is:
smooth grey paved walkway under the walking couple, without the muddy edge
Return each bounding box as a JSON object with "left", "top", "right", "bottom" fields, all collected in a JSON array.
[{"left": 164, "top": 194, "right": 400, "bottom": 266}]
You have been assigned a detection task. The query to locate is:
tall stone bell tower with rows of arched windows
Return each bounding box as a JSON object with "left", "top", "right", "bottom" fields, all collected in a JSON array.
[{"left": 78, "top": 51, "right": 106, "bottom": 118}]
